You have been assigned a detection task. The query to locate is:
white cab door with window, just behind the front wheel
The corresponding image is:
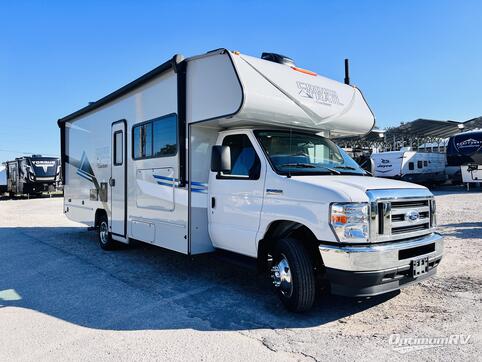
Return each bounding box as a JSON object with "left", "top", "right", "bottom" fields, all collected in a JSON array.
[{"left": 208, "top": 134, "right": 265, "bottom": 256}]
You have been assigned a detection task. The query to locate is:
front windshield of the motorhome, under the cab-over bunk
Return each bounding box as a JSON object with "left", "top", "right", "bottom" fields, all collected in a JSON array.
[{"left": 255, "top": 131, "right": 366, "bottom": 175}]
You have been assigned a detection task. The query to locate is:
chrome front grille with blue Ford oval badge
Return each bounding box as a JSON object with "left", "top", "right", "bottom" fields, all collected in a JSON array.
[{"left": 367, "top": 189, "right": 435, "bottom": 242}]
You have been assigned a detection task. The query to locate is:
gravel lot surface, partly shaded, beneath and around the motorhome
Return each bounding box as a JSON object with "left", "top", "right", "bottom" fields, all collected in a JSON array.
[{"left": 0, "top": 190, "right": 482, "bottom": 361}]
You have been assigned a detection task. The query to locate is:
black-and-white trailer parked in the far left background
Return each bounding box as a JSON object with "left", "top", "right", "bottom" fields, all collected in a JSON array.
[{"left": 5, "top": 155, "right": 61, "bottom": 197}]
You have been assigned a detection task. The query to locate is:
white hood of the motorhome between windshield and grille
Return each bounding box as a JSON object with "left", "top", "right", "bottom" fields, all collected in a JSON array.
[{"left": 292, "top": 175, "right": 426, "bottom": 201}]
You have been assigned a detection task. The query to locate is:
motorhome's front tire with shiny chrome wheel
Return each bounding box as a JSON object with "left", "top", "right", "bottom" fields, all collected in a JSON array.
[{"left": 271, "top": 237, "right": 316, "bottom": 312}]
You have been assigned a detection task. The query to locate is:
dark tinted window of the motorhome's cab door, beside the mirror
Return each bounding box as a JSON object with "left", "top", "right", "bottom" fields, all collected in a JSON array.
[{"left": 221, "top": 135, "right": 261, "bottom": 180}]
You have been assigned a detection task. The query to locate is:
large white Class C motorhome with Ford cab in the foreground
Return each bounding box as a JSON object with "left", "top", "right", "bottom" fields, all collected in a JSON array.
[{"left": 58, "top": 49, "right": 443, "bottom": 311}]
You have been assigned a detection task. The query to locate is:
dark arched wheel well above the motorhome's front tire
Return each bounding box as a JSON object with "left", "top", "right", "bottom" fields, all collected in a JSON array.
[{"left": 258, "top": 220, "right": 323, "bottom": 270}]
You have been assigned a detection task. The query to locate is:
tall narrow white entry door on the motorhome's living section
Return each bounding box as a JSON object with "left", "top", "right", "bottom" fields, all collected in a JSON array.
[{"left": 109, "top": 121, "right": 127, "bottom": 237}]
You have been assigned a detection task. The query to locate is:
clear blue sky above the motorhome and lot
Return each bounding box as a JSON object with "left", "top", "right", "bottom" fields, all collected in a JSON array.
[{"left": 0, "top": 0, "right": 482, "bottom": 162}]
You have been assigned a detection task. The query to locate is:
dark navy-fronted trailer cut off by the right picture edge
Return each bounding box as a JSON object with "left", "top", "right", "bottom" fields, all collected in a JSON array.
[{"left": 447, "top": 130, "right": 482, "bottom": 187}]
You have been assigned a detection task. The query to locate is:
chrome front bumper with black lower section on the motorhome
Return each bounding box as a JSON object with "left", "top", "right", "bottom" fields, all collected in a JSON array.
[{"left": 319, "top": 233, "right": 443, "bottom": 297}]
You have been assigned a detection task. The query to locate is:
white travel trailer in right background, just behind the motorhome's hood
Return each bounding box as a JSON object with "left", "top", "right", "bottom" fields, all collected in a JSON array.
[{"left": 371, "top": 150, "right": 447, "bottom": 185}]
